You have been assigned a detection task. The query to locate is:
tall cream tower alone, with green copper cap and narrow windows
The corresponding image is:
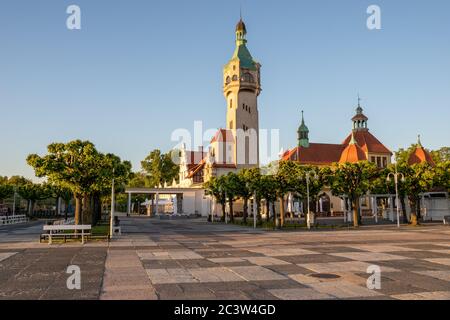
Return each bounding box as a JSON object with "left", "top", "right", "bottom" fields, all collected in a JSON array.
[{"left": 223, "top": 18, "right": 261, "bottom": 169}]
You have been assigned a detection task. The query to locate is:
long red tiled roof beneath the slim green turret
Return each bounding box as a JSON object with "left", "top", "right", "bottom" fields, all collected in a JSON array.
[{"left": 282, "top": 143, "right": 345, "bottom": 165}]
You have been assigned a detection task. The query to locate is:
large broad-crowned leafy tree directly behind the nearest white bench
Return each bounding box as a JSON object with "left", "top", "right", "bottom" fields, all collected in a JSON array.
[{"left": 27, "top": 140, "right": 132, "bottom": 224}]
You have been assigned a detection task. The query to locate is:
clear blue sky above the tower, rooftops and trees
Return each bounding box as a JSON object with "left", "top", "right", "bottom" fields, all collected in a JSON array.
[{"left": 0, "top": 0, "right": 450, "bottom": 177}]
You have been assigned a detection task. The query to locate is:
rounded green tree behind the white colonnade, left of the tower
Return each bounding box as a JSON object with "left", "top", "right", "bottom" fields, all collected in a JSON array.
[{"left": 141, "top": 149, "right": 179, "bottom": 188}]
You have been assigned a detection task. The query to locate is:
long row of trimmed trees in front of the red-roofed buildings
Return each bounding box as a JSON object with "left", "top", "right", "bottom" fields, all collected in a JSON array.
[{"left": 205, "top": 161, "right": 450, "bottom": 226}]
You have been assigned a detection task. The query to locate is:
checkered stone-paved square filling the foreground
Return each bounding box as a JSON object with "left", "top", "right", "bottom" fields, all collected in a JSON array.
[{"left": 0, "top": 217, "right": 450, "bottom": 300}]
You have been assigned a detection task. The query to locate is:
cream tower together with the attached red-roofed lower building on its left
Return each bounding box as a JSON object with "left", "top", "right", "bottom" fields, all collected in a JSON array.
[{"left": 180, "top": 18, "right": 261, "bottom": 186}]
